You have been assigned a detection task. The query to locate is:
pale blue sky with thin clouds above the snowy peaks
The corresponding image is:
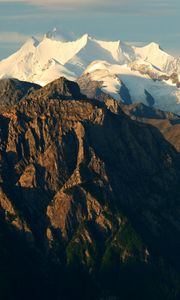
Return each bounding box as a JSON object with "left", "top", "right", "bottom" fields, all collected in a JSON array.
[{"left": 0, "top": 0, "right": 180, "bottom": 59}]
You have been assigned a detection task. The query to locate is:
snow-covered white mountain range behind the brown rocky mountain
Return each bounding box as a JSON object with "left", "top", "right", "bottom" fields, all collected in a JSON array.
[{"left": 0, "top": 29, "right": 180, "bottom": 114}]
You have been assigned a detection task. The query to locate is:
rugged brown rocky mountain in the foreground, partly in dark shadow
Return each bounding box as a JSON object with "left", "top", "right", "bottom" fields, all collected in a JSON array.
[{"left": 0, "top": 78, "right": 180, "bottom": 300}]
